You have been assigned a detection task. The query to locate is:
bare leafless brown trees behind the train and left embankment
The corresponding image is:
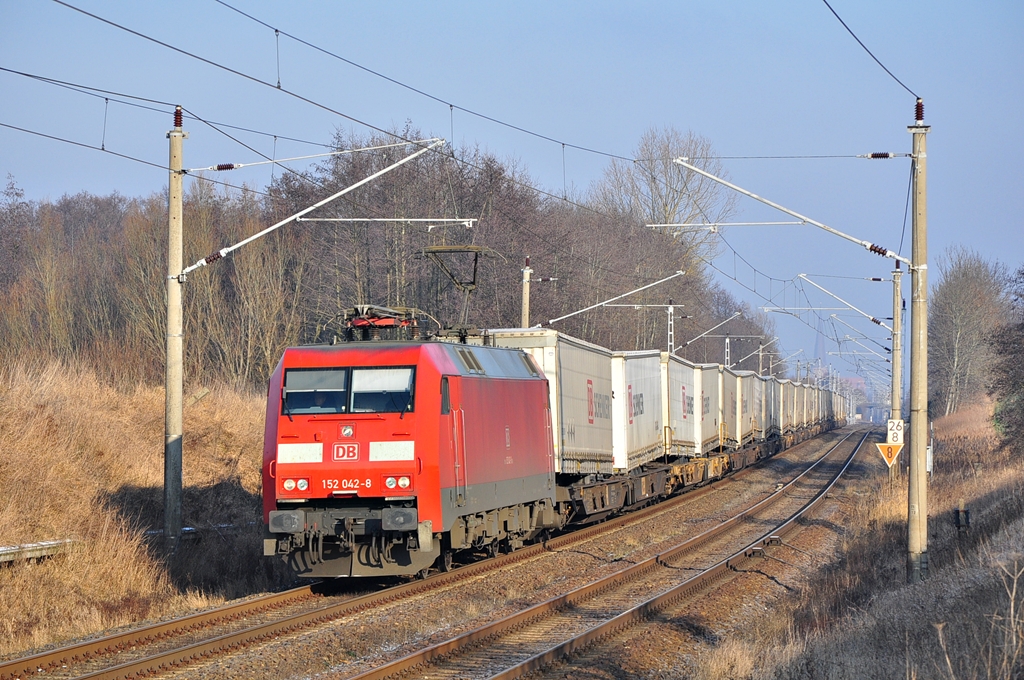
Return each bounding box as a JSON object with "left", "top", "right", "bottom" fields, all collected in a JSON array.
[{"left": 0, "top": 127, "right": 784, "bottom": 387}]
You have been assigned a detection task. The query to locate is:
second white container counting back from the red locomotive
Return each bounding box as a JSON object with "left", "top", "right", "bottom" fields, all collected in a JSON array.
[{"left": 611, "top": 349, "right": 665, "bottom": 472}]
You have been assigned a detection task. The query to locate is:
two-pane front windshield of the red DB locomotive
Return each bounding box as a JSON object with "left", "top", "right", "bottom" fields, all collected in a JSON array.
[{"left": 281, "top": 368, "right": 415, "bottom": 416}]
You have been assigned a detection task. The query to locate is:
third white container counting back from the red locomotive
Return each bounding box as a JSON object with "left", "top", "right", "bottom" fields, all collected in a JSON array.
[{"left": 662, "top": 352, "right": 701, "bottom": 458}]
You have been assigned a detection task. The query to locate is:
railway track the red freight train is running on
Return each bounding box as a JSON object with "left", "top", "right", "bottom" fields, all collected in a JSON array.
[{"left": 0, "top": 430, "right": 851, "bottom": 680}]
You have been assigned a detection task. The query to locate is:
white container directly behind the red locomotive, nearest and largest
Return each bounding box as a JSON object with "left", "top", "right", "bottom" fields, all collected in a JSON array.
[{"left": 485, "top": 329, "right": 614, "bottom": 474}]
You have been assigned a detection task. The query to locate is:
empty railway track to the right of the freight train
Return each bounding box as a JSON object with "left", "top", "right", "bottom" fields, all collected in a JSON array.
[{"left": 354, "top": 432, "right": 869, "bottom": 680}]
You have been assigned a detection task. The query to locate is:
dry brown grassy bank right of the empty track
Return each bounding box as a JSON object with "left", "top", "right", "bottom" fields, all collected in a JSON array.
[{"left": 698, "top": 405, "right": 1024, "bottom": 680}]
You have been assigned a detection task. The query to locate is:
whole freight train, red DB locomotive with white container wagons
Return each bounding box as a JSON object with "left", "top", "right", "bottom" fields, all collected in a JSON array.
[{"left": 263, "top": 329, "right": 848, "bottom": 578}]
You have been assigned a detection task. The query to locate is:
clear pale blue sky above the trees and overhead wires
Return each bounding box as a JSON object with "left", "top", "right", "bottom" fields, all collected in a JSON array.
[{"left": 0, "top": 0, "right": 1024, "bottom": 395}]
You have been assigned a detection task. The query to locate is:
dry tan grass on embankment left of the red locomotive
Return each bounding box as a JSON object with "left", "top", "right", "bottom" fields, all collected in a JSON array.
[{"left": 0, "top": 363, "right": 292, "bottom": 654}]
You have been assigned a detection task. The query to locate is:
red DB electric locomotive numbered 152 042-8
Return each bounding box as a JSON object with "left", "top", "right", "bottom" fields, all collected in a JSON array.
[{"left": 263, "top": 342, "right": 560, "bottom": 577}]
